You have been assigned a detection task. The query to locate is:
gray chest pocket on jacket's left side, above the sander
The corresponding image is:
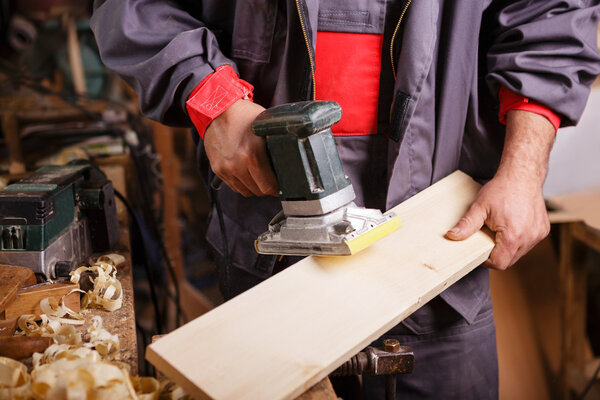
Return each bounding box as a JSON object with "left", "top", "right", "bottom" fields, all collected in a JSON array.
[{"left": 231, "top": 0, "right": 278, "bottom": 64}]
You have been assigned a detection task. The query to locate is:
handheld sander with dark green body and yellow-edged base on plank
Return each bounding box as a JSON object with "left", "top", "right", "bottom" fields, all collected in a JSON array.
[{"left": 252, "top": 101, "right": 400, "bottom": 256}]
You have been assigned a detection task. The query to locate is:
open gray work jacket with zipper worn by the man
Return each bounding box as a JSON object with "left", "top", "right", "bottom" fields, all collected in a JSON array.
[{"left": 91, "top": 0, "right": 600, "bottom": 320}]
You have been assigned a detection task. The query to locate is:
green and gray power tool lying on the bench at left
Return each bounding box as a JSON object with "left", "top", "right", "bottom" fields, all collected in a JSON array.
[{"left": 0, "top": 161, "right": 120, "bottom": 279}]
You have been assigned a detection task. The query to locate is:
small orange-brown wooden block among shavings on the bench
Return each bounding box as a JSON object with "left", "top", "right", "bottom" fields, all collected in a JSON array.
[{"left": 5, "top": 283, "right": 80, "bottom": 319}]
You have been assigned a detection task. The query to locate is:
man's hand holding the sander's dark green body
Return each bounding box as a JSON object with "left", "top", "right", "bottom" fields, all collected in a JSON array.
[{"left": 204, "top": 100, "right": 279, "bottom": 197}]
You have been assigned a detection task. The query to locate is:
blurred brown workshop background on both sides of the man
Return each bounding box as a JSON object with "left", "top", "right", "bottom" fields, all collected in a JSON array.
[{"left": 0, "top": 0, "right": 600, "bottom": 399}]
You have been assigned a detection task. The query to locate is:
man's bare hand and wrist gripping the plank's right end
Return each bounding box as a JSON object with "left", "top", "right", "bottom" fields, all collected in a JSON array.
[{"left": 446, "top": 110, "right": 556, "bottom": 270}]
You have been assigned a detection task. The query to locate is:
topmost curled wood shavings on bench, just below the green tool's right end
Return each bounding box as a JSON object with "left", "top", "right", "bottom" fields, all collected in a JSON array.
[{"left": 71, "top": 254, "right": 125, "bottom": 311}]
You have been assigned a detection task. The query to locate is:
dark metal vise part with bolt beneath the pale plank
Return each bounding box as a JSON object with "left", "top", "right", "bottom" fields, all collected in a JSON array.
[{"left": 331, "top": 339, "right": 415, "bottom": 400}]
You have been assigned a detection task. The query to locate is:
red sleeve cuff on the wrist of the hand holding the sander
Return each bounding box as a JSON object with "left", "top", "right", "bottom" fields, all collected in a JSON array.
[{"left": 185, "top": 64, "right": 254, "bottom": 139}]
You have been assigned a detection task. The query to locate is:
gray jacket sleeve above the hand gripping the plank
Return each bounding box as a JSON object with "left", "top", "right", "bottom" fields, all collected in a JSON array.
[{"left": 483, "top": 0, "right": 600, "bottom": 126}]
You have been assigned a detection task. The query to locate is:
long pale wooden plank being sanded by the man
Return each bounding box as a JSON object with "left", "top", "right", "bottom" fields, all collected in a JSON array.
[{"left": 146, "top": 172, "right": 494, "bottom": 399}]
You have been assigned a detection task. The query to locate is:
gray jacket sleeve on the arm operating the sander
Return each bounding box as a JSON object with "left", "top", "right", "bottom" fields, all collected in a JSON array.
[{"left": 91, "top": 0, "right": 235, "bottom": 126}]
